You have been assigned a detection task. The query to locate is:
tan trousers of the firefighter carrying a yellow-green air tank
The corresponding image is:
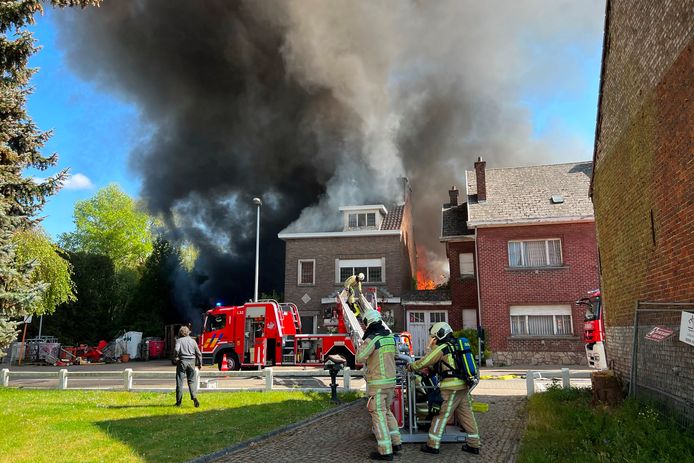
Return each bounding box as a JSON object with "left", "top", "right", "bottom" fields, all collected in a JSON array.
[{"left": 427, "top": 388, "right": 480, "bottom": 449}]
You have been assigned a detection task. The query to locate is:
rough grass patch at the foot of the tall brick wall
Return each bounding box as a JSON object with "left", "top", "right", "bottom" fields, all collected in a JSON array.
[{"left": 519, "top": 388, "right": 694, "bottom": 463}]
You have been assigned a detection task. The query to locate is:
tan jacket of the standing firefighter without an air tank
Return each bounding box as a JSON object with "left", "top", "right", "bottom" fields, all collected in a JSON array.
[{"left": 356, "top": 331, "right": 395, "bottom": 394}]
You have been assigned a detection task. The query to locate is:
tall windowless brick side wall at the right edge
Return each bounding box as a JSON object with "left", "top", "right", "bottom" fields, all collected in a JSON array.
[{"left": 591, "top": 0, "right": 694, "bottom": 398}]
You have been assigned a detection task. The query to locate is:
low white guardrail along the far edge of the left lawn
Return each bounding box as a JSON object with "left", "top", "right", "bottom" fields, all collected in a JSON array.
[{"left": 0, "top": 368, "right": 364, "bottom": 392}]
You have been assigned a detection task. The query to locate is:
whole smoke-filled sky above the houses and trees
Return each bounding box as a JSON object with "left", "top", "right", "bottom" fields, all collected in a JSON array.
[{"left": 30, "top": 0, "right": 604, "bottom": 302}]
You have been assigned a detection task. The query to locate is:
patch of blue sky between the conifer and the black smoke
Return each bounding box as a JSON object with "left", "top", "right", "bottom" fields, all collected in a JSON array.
[{"left": 28, "top": 9, "right": 143, "bottom": 241}]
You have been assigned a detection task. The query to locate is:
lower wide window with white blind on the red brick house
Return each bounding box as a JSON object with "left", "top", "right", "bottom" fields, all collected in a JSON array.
[{"left": 511, "top": 305, "right": 573, "bottom": 336}]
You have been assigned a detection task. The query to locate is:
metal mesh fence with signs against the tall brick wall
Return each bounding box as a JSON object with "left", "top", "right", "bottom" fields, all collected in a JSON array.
[{"left": 629, "top": 302, "right": 694, "bottom": 429}]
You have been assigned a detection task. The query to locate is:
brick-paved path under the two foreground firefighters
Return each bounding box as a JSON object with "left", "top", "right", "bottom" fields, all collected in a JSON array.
[{"left": 214, "top": 394, "right": 526, "bottom": 463}]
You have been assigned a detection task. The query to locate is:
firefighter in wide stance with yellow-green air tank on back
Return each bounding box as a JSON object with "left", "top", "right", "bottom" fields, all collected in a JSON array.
[{"left": 407, "top": 322, "right": 480, "bottom": 455}]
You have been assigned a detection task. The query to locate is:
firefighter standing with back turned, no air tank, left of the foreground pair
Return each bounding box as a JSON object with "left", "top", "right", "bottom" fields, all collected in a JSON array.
[{"left": 356, "top": 310, "right": 402, "bottom": 461}]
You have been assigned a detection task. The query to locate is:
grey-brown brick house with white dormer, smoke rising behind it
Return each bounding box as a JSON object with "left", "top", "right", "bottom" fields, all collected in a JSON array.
[{"left": 278, "top": 184, "right": 416, "bottom": 333}]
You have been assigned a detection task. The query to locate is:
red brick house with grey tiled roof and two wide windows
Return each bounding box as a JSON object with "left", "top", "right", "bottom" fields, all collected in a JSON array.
[{"left": 448, "top": 159, "right": 599, "bottom": 365}]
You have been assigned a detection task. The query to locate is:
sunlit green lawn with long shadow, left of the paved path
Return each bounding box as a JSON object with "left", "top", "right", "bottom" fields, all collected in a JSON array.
[{"left": 0, "top": 388, "right": 357, "bottom": 463}]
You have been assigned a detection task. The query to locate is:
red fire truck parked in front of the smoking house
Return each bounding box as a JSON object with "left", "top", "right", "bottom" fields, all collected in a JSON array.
[{"left": 198, "top": 300, "right": 355, "bottom": 370}]
